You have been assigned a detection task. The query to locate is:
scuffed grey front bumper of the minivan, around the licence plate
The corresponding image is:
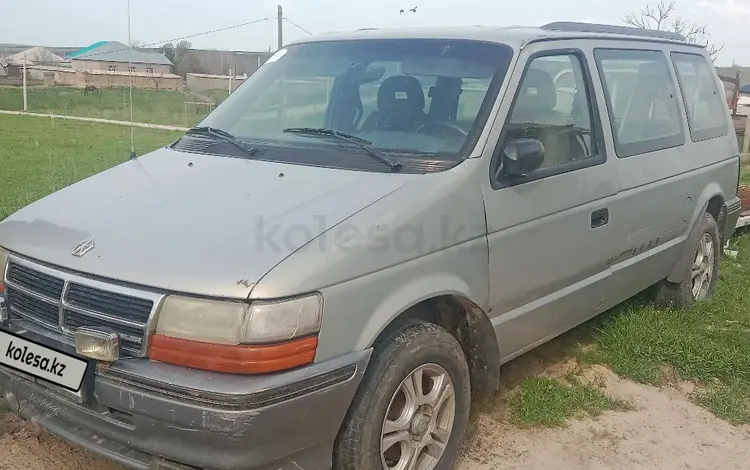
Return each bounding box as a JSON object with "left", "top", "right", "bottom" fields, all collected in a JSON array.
[{"left": 0, "top": 323, "right": 370, "bottom": 470}]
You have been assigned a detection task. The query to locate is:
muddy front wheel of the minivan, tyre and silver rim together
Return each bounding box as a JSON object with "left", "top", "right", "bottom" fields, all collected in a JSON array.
[{"left": 333, "top": 322, "right": 471, "bottom": 470}]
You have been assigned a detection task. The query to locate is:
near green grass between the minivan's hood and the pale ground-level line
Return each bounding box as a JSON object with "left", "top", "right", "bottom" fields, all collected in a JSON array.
[{"left": 0, "top": 115, "right": 180, "bottom": 220}]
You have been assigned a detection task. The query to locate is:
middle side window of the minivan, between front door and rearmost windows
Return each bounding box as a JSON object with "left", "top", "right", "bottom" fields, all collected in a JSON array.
[{"left": 594, "top": 49, "right": 685, "bottom": 157}]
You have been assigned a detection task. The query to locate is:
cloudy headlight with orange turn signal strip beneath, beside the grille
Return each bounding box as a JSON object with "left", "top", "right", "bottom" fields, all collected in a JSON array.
[{"left": 149, "top": 294, "right": 323, "bottom": 373}]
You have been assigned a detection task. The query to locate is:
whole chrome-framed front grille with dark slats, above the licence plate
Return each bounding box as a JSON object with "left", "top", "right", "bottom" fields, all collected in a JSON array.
[{"left": 6, "top": 259, "right": 161, "bottom": 357}]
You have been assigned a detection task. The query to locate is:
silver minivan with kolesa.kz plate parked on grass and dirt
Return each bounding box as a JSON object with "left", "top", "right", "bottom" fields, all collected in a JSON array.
[{"left": 0, "top": 23, "right": 740, "bottom": 470}]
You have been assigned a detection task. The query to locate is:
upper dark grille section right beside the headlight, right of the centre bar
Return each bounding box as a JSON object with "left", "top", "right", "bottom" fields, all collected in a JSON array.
[{"left": 65, "top": 284, "right": 154, "bottom": 323}]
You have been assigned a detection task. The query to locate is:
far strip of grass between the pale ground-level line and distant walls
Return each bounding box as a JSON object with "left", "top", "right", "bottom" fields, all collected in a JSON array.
[{"left": 0, "top": 86, "right": 212, "bottom": 126}]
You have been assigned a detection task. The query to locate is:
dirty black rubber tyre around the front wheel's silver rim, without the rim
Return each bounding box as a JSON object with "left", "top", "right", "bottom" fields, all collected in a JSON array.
[{"left": 333, "top": 321, "right": 471, "bottom": 470}]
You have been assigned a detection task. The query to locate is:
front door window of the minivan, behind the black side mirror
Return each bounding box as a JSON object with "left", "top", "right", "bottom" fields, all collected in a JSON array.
[{"left": 505, "top": 54, "right": 596, "bottom": 168}]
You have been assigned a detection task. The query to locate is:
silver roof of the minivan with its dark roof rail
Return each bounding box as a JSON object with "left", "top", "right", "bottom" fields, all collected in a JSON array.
[{"left": 293, "top": 23, "right": 702, "bottom": 49}]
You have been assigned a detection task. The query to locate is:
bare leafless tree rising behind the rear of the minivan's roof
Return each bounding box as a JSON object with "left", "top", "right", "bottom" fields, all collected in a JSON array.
[{"left": 622, "top": 0, "right": 724, "bottom": 60}]
